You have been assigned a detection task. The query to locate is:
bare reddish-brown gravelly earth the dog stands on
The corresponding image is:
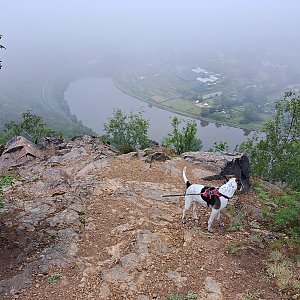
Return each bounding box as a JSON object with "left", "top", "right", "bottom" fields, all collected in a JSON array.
[{"left": 0, "top": 144, "right": 280, "bottom": 300}]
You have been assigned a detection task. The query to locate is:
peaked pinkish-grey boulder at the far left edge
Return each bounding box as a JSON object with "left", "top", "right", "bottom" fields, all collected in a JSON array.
[{"left": 0, "top": 136, "right": 44, "bottom": 173}]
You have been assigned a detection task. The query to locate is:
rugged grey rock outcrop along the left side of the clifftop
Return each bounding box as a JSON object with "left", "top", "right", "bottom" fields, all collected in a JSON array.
[{"left": 0, "top": 136, "right": 115, "bottom": 295}]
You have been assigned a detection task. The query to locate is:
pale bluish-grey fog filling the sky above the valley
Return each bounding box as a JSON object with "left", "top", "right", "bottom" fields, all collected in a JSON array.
[{"left": 0, "top": 0, "right": 300, "bottom": 142}]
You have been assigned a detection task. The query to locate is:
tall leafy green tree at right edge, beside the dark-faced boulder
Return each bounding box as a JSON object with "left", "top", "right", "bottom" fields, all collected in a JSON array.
[{"left": 240, "top": 92, "right": 300, "bottom": 190}]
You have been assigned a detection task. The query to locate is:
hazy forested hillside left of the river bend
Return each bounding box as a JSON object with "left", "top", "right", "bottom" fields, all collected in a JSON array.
[{"left": 0, "top": 63, "right": 113, "bottom": 136}]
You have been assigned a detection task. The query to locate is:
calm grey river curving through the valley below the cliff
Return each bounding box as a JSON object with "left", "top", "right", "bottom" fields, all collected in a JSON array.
[{"left": 65, "top": 78, "right": 250, "bottom": 151}]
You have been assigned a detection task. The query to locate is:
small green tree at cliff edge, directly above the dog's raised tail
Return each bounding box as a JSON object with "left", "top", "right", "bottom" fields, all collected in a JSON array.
[{"left": 163, "top": 117, "right": 202, "bottom": 154}]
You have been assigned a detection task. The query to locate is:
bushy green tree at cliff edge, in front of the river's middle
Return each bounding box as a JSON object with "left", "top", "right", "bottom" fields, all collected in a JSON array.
[{"left": 103, "top": 109, "right": 149, "bottom": 153}]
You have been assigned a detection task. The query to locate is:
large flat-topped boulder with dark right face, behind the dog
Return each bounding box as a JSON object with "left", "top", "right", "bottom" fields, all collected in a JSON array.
[{"left": 182, "top": 152, "right": 250, "bottom": 189}]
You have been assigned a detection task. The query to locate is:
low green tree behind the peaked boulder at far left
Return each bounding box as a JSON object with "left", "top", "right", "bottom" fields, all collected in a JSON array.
[{"left": 0, "top": 110, "right": 60, "bottom": 144}]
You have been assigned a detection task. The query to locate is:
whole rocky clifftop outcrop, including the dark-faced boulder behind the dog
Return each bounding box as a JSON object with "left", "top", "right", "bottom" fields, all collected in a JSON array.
[{"left": 0, "top": 136, "right": 264, "bottom": 300}]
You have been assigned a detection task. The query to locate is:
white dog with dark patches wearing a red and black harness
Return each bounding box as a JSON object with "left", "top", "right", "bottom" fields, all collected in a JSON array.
[{"left": 182, "top": 167, "right": 242, "bottom": 232}]
